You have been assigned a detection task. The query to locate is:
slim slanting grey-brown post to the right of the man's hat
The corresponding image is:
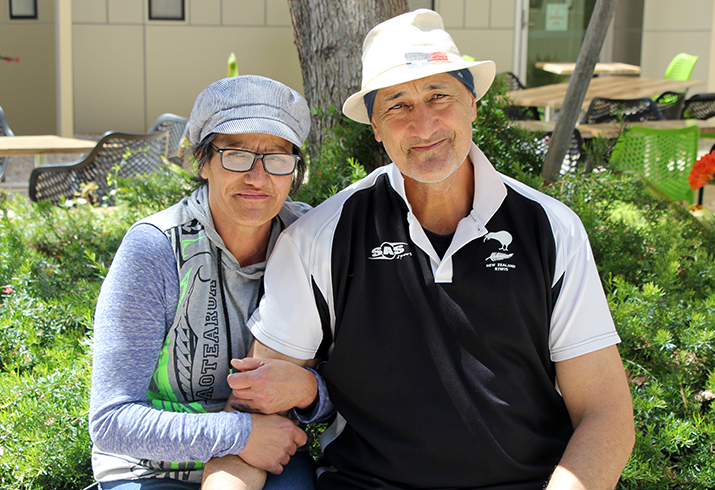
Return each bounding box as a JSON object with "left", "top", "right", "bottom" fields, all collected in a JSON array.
[{"left": 541, "top": 0, "right": 618, "bottom": 182}]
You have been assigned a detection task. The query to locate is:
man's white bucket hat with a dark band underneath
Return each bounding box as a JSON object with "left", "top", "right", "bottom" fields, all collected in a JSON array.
[{"left": 343, "top": 9, "right": 496, "bottom": 124}]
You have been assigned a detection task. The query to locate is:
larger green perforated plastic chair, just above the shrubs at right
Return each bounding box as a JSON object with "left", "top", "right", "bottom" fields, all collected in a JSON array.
[{"left": 611, "top": 126, "right": 700, "bottom": 204}]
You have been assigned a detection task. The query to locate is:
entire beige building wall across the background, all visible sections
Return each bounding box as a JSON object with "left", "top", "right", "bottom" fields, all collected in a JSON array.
[{"left": 7, "top": 0, "right": 715, "bottom": 134}]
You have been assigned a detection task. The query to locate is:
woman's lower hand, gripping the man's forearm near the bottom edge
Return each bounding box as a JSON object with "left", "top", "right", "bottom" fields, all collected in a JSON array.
[{"left": 238, "top": 414, "right": 308, "bottom": 475}]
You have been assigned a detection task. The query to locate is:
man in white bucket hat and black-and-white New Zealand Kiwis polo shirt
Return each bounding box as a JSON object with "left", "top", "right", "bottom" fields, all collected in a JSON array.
[{"left": 229, "top": 10, "right": 634, "bottom": 490}]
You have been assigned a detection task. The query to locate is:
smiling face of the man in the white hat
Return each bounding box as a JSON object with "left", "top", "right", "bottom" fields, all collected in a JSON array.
[{"left": 371, "top": 73, "right": 477, "bottom": 184}]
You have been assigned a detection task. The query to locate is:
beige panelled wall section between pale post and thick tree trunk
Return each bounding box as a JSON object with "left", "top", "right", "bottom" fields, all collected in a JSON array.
[{"left": 72, "top": 0, "right": 303, "bottom": 133}]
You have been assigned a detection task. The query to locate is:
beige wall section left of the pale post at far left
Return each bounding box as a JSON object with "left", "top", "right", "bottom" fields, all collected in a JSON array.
[{"left": 0, "top": 0, "right": 57, "bottom": 134}]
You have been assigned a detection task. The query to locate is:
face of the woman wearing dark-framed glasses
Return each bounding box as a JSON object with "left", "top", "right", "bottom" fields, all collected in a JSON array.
[{"left": 201, "top": 133, "right": 293, "bottom": 236}]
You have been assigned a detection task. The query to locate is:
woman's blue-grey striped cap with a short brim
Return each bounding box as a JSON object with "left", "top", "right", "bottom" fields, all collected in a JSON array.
[{"left": 186, "top": 75, "right": 310, "bottom": 148}]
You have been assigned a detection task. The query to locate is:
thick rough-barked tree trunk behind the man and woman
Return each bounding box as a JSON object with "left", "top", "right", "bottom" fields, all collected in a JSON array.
[{"left": 288, "top": 0, "right": 408, "bottom": 165}]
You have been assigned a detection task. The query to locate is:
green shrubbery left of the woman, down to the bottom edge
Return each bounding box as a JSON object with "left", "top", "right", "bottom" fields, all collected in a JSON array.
[{"left": 0, "top": 167, "right": 191, "bottom": 490}]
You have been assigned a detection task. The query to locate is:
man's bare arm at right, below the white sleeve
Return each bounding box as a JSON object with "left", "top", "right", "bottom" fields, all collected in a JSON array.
[{"left": 547, "top": 345, "right": 635, "bottom": 490}]
